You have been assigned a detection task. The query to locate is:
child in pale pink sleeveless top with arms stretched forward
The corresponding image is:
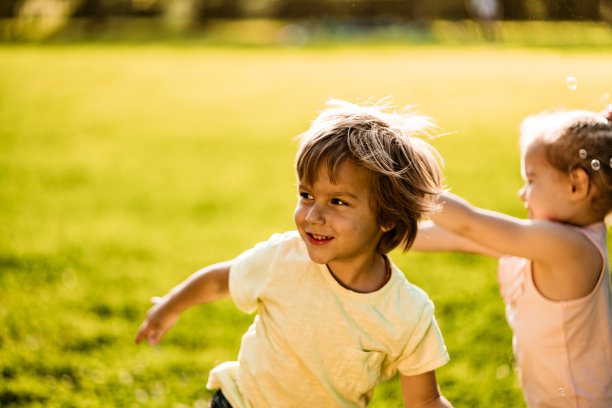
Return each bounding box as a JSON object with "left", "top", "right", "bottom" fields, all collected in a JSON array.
[{"left": 414, "top": 105, "right": 612, "bottom": 408}]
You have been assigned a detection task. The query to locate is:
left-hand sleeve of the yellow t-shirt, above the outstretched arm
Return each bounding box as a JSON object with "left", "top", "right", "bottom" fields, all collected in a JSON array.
[{"left": 229, "top": 234, "right": 281, "bottom": 313}]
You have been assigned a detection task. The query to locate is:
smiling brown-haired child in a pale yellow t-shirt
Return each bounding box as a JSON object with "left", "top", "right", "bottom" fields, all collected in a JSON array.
[{"left": 136, "top": 101, "right": 450, "bottom": 408}]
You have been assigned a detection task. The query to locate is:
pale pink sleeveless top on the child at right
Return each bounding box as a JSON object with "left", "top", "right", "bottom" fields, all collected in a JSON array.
[{"left": 498, "top": 223, "right": 612, "bottom": 408}]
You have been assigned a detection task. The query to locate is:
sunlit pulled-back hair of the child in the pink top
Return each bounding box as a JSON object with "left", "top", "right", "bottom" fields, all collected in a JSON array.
[{"left": 520, "top": 110, "right": 612, "bottom": 218}]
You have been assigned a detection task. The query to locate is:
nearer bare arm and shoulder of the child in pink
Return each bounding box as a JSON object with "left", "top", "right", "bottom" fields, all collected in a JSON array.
[{"left": 431, "top": 194, "right": 603, "bottom": 300}]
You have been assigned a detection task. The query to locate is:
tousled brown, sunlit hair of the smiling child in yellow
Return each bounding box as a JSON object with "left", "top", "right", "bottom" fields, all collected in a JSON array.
[{"left": 295, "top": 99, "right": 442, "bottom": 253}]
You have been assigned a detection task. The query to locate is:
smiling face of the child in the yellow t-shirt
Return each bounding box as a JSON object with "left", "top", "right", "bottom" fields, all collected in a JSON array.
[{"left": 294, "top": 161, "right": 383, "bottom": 270}]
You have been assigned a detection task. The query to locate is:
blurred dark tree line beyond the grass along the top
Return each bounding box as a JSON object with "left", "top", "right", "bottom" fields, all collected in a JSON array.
[{"left": 0, "top": 0, "right": 612, "bottom": 41}]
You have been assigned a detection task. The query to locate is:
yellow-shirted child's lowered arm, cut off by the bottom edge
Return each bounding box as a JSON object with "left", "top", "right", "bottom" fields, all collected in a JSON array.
[{"left": 400, "top": 371, "right": 453, "bottom": 408}]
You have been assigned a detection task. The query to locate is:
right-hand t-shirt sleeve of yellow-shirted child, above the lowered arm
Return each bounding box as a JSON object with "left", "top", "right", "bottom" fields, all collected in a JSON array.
[{"left": 397, "top": 300, "right": 449, "bottom": 375}]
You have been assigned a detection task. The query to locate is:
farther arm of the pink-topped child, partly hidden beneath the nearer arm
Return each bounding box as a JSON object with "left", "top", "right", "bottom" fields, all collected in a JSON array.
[{"left": 411, "top": 220, "right": 502, "bottom": 258}]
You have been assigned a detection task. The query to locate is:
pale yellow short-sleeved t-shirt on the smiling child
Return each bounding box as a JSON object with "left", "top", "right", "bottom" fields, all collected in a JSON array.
[{"left": 207, "top": 231, "right": 449, "bottom": 408}]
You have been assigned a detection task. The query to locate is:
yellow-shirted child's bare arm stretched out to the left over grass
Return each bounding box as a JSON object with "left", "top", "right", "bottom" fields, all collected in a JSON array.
[{"left": 136, "top": 261, "right": 232, "bottom": 344}]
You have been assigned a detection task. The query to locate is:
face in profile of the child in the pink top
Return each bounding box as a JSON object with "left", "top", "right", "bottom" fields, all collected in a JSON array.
[{"left": 519, "top": 145, "right": 572, "bottom": 222}]
